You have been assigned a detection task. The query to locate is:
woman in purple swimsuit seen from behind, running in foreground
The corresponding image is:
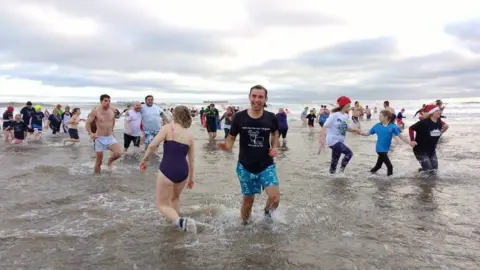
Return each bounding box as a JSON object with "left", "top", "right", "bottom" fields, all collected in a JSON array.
[{"left": 140, "top": 106, "right": 195, "bottom": 231}]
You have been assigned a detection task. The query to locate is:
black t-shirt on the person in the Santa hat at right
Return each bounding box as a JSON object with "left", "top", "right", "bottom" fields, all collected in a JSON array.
[{"left": 410, "top": 119, "right": 442, "bottom": 152}]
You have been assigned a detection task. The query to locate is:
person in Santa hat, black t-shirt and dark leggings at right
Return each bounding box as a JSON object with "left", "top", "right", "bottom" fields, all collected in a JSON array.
[{"left": 409, "top": 105, "right": 448, "bottom": 176}]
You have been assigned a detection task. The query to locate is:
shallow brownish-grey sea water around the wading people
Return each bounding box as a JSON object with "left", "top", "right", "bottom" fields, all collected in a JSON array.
[{"left": 0, "top": 100, "right": 480, "bottom": 270}]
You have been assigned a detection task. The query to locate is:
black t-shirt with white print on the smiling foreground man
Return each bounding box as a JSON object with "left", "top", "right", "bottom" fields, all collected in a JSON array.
[{"left": 230, "top": 110, "right": 278, "bottom": 173}]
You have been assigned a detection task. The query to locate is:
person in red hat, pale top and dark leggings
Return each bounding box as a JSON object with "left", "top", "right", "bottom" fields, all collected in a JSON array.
[{"left": 320, "top": 96, "right": 359, "bottom": 174}]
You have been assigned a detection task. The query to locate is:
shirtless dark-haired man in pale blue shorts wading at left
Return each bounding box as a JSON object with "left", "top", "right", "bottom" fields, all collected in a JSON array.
[{"left": 85, "top": 94, "right": 121, "bottom": 173}]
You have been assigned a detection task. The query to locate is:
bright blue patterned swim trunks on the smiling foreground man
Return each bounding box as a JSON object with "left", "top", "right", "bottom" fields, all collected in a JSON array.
[{"left": 237, "top": 162, "right": 279, "bottom": 196}]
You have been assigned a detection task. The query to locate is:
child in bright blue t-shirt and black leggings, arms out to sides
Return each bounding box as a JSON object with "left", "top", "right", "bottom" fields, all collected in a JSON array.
[{"left": 360, "top": 110, "right": 410, "bottom": 176}]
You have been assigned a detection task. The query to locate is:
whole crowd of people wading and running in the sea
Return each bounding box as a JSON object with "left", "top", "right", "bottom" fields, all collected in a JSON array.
[{"left": 3, "top": 85, "right": 448, "bottom": 231}]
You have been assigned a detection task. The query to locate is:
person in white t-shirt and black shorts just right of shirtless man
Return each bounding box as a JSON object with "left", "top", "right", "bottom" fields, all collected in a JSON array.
[{"left": 123, "top": 102, "right": 142, "bottom": 152}]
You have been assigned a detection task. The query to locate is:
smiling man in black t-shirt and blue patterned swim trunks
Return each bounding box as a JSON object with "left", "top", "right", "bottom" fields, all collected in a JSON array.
[{"left": 218, "top": 85, "right": 280, "bottom": 224}]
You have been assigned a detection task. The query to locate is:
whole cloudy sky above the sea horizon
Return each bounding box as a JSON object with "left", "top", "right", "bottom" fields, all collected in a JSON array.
[{"left": 0, "top": 0, "right": 480, "bottom": 102}]
